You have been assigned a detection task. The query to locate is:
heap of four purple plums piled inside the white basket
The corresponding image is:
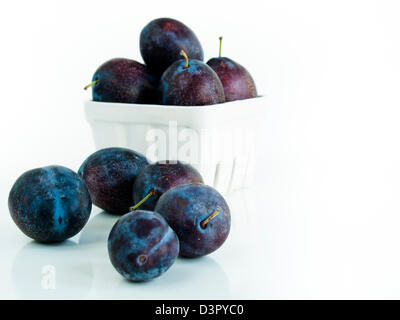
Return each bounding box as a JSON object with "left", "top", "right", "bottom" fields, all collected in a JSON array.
[{"left": 85, "top": 18, "right": 257, "bottom": 106}]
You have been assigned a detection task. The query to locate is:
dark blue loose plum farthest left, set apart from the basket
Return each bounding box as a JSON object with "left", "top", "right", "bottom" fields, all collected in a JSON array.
[{"left": 8, "top": 166, "right": 92, "bottom": 242}]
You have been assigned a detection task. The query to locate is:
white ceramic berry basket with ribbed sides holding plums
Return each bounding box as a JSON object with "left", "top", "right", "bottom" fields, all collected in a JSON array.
[{"left": 85, "top": 97, "right": 267, "bottom": 194}]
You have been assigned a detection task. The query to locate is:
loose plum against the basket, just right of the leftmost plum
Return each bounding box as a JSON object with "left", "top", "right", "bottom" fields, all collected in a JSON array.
[{"left": 78, "top": 148, "right": 148, "bottom": 214}]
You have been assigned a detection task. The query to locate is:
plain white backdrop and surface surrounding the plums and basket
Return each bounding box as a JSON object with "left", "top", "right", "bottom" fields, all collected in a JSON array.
[{"left": 0, "top": 0, "right": 400, "bottom": 299}]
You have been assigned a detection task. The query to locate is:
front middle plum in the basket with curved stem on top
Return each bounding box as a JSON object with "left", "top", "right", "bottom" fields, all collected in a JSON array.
[{"left": 158, "top": 51, "right": 225, "bottom": 106}]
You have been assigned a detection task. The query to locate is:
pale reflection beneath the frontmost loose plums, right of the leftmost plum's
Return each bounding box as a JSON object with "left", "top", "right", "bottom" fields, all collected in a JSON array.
[{"left": 79, "top": 212, "right": 230, "bottom": 299}]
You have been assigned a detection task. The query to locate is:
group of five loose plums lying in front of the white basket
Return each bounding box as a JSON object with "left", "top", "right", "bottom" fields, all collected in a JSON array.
[{"left": 8, "top": 147, "right": 231, "bottom": 281}]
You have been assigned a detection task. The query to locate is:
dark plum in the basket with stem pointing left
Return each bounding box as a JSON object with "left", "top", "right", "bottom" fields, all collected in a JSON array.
[{"left": 85, "top": 58, "right": 158, "bottom": 104}]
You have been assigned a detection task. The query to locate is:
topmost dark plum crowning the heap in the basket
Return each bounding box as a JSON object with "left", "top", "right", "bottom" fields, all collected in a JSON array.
[{"left": 140, "top": 18, "right": 204, "bottom": 76}]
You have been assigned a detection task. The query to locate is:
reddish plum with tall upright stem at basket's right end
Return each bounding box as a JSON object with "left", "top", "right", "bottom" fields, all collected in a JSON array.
[{"left": 207, "top": 37, "right": 257, "bottom": 102}]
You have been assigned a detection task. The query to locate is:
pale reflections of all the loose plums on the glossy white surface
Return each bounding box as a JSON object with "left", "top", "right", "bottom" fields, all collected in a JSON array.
[{"left": 7, "top": 212, "right": 231, "bottom": 299}]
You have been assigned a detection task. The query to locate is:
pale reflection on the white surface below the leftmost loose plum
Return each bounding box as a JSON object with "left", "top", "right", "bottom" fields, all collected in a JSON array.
[{"left": 12, "top": 241, "right": 93, "bottom": 299}]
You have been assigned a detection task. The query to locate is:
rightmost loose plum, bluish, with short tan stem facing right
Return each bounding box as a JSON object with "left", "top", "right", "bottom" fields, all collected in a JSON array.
[{"left": 155, "top": 183, "right": 231, "bottom": 257}]
